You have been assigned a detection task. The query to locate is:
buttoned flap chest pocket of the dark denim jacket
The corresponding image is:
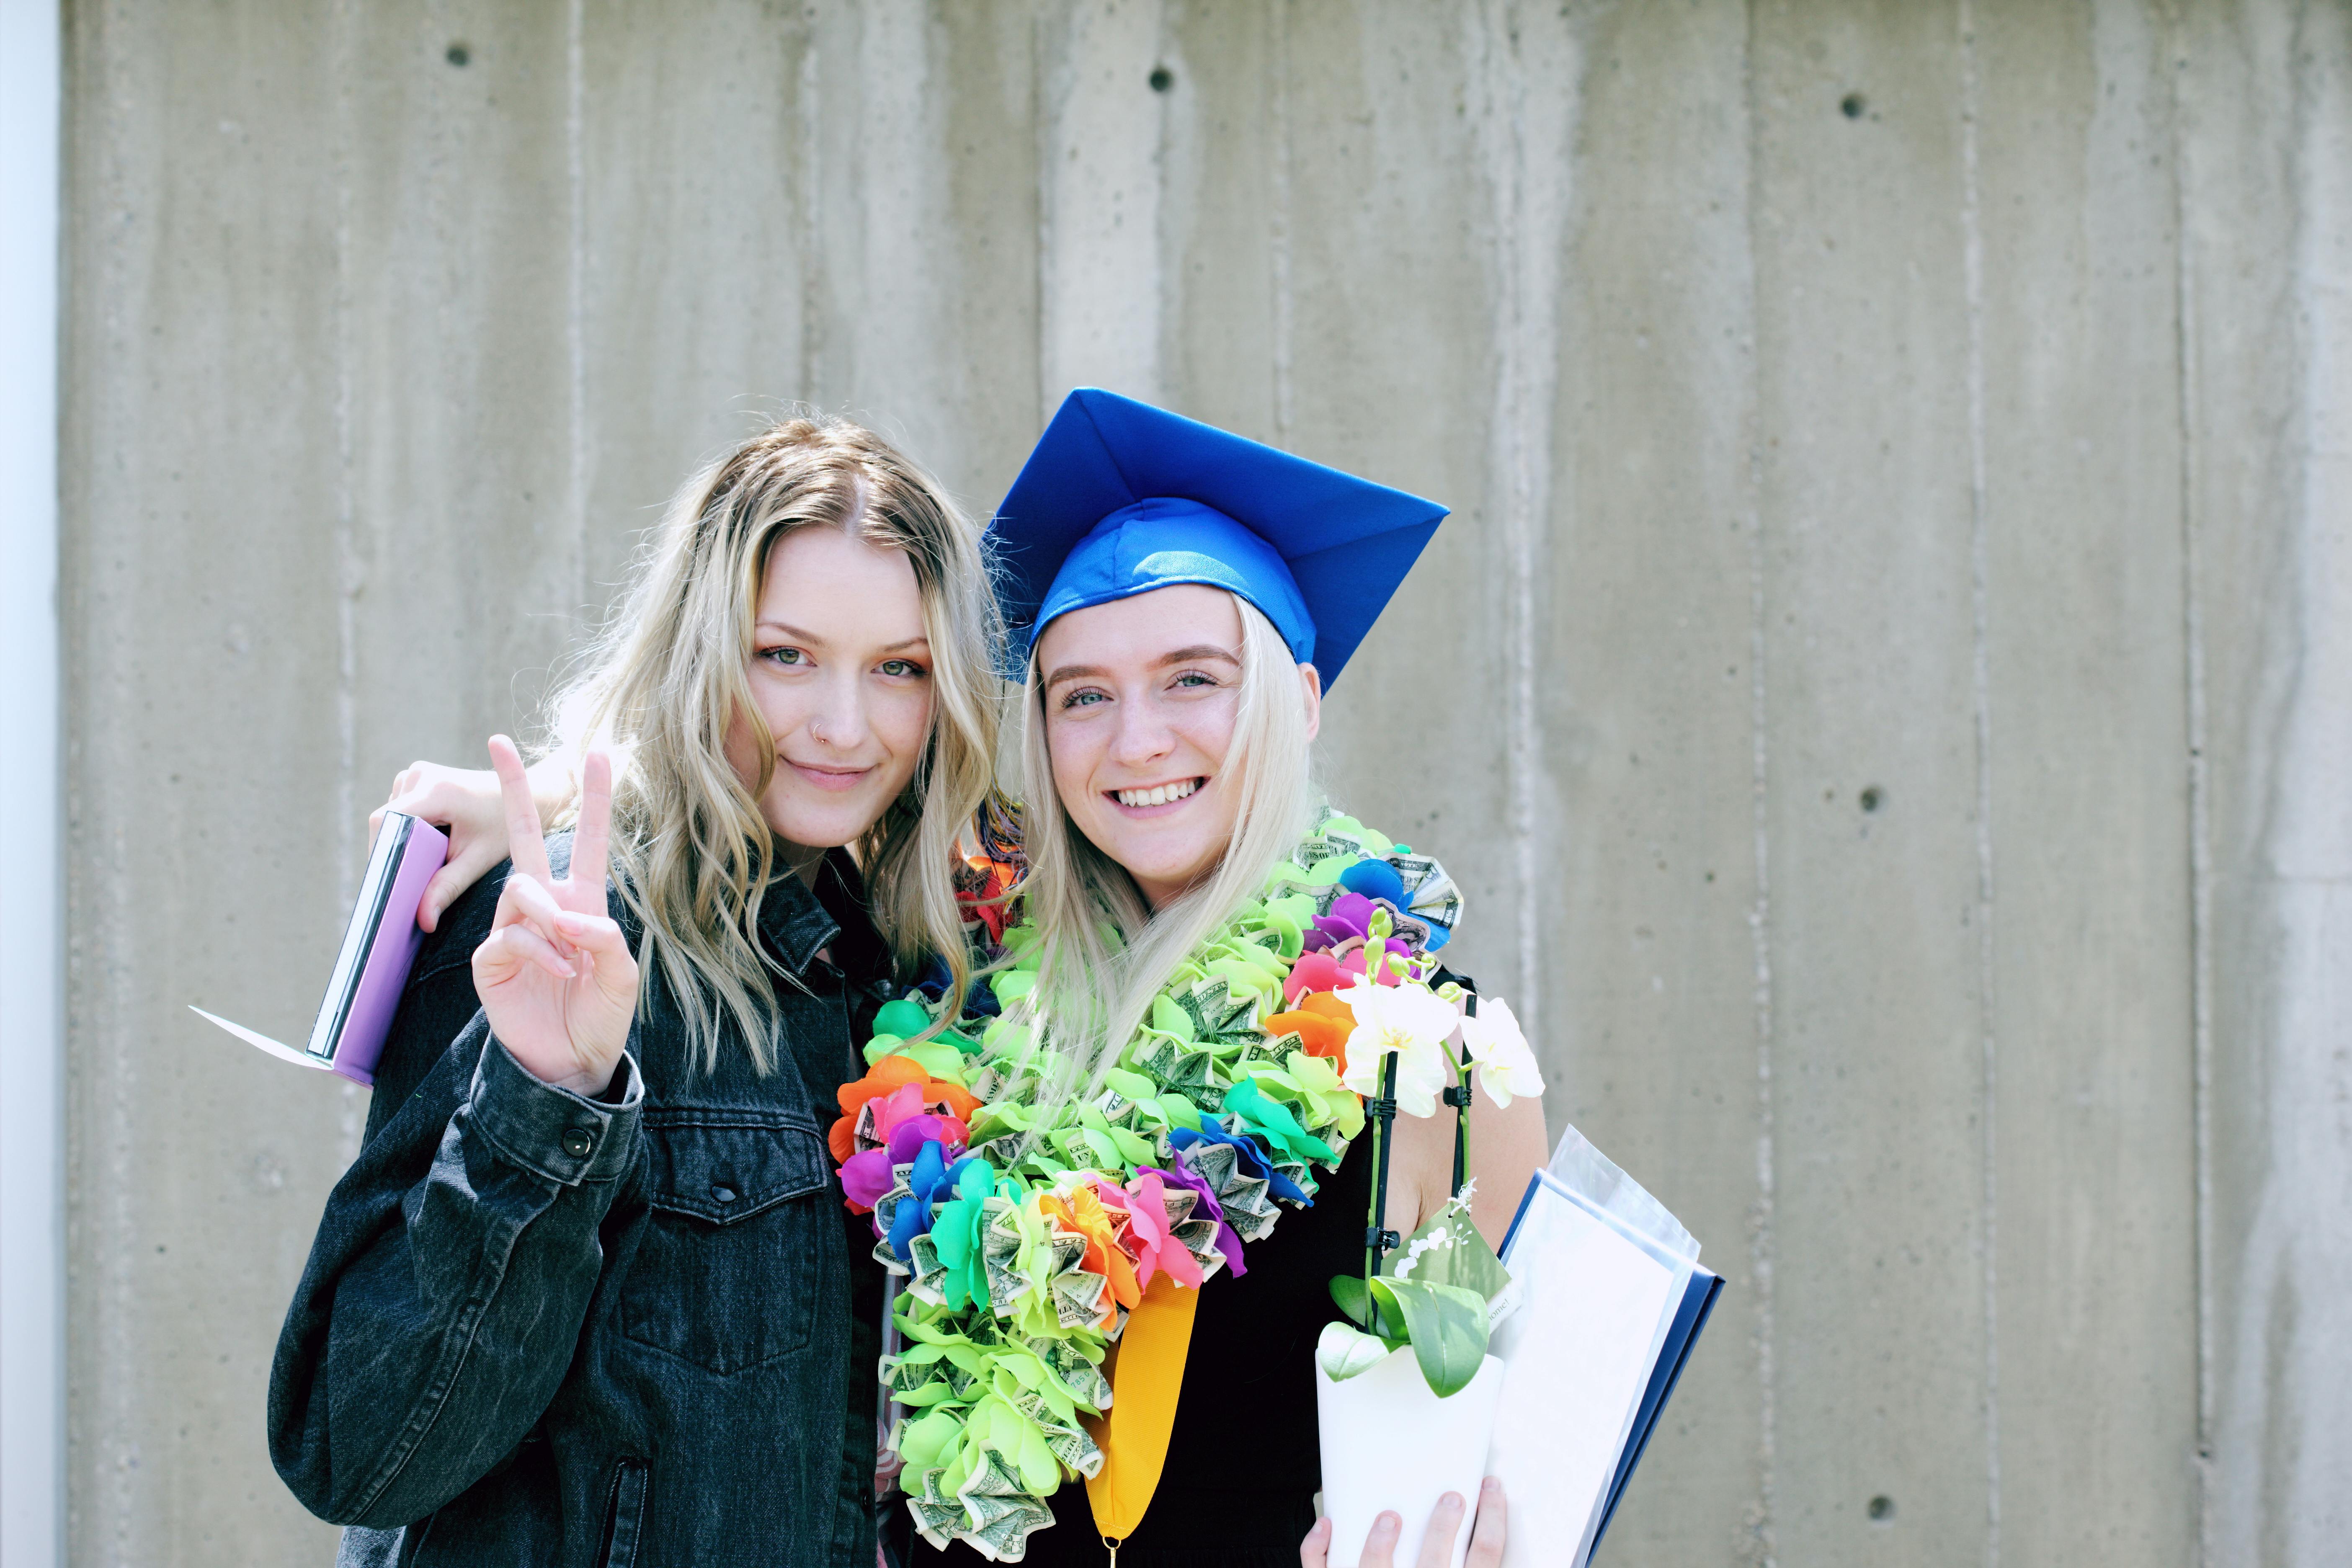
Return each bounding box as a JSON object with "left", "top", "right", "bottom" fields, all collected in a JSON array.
[{"left": 621, "top": 1105, "right": 840, "bottom": 1375}]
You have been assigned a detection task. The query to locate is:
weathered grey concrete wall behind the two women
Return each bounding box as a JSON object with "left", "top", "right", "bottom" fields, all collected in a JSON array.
[{"left": 61, "top": 0, "right": 2352, "bottom": 1568}]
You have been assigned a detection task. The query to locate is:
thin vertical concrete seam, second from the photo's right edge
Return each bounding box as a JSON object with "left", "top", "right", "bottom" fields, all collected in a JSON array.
[{"left": 1959, "top": 0, "right": 2001, "bottom": 1568}]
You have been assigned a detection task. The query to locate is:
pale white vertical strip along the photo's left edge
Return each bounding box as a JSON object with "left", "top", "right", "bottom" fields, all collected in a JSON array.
[{"left": 0, "top": 0, "right": 66, "bottom": 1568}]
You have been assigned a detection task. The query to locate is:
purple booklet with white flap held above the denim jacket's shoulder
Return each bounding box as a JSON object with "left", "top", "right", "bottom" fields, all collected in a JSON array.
[{"left": 193, "top": 811, "right": 449, "bottom": 1084}]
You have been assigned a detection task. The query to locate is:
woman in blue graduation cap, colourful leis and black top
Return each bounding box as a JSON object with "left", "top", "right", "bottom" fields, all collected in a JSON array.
[{"left": 856, "top": 390, "right": 1545, "bottom": 1568}]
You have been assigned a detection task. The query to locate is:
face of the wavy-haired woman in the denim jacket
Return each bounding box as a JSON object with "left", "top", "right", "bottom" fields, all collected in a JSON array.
[{"left": 727, "top": 526, "right": 931, "bottom": 848}]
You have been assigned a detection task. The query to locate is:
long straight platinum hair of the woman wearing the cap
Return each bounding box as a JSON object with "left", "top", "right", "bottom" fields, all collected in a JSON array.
[{"left": 1002, "top": 595, "right": 1317, "bottom": 1126}]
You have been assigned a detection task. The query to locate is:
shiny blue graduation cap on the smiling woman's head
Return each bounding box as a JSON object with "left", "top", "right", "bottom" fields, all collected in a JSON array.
[{"left": 988, "top": 388, "right": 1447, "bottom": 689}]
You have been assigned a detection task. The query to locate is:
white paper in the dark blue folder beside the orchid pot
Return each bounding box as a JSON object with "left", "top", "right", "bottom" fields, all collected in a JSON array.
[{"left": 1486, "top": 1173, "right": 1691, "bottom": 1568}]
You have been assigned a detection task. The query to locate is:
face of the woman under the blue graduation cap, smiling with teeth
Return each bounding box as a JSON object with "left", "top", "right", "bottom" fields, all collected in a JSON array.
[{"left": 1037, "top": 583, "right": 1320, "bottom": 910}]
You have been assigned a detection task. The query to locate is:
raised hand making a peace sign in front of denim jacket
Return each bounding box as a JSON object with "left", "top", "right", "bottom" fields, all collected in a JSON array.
[{"left": 473, "top": 736, "right": 637, "bottom": 1096}]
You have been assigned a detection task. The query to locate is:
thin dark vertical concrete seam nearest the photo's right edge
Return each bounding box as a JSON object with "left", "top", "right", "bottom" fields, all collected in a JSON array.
[{"left": 2166, "top": 12, "right": 2215, "bottom": 1568}]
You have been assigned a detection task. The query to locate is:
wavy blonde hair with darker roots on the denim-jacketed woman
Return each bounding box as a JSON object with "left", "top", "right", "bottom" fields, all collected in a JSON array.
[{"left": 553, "top": 418, "right": 1002, "bottom": 1072}]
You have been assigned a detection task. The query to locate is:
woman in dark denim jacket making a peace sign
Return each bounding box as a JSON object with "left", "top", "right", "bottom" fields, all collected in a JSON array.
[{"left": 271, "top": 421, "right": 997, "bottom": 1568}]
